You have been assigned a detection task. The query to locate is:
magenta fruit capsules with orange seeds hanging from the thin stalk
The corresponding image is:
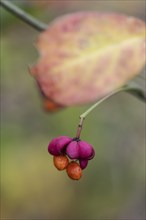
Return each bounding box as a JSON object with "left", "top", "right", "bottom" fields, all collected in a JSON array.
[{"left": 48, "top": 136, "right": 95, "bottom": 180}]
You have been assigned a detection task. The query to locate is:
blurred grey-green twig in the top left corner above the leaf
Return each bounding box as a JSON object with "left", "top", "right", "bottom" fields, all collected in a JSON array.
[{"left": 0, "top": 0, "right": 47, "bottom": 31}]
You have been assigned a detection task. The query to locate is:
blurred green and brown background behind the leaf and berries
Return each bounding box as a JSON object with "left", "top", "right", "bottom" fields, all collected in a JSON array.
[{"left": 1, "top": 0, "right": 146, "bottom": 220}]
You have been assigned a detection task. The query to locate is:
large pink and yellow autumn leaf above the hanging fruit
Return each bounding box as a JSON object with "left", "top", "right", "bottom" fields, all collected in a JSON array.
[{"left": 30, "top": 12, "right": 145, "bottom": 109}]
